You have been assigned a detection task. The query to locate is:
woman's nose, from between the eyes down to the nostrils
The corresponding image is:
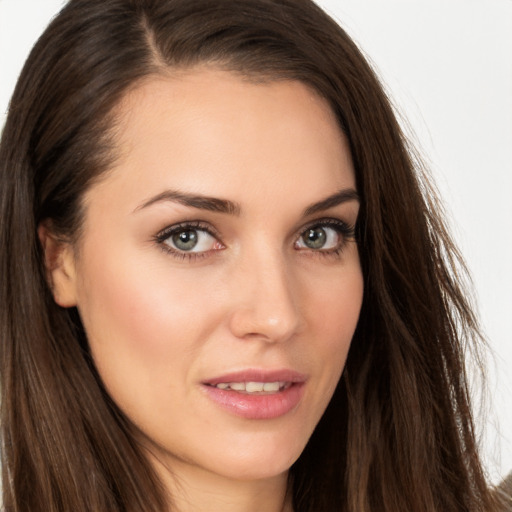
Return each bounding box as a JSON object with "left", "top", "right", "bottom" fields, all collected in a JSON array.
[{"left": 229, "top": 245, "right": 303, "bottom": 342}]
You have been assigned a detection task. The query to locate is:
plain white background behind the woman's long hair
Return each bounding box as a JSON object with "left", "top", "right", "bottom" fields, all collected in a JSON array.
[{"left": 0, "top": 0, "right": 512, "bottom": 482}]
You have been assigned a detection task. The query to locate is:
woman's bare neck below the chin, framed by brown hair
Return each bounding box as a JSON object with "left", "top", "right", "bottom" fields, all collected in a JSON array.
[{"left": 147, "top": 450, "right": 293, "bottom": 512}]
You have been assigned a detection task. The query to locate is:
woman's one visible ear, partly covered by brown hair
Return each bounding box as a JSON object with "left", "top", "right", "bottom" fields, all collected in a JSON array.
[{"left": 37, "top": 221, "right": 76, "bottom": 308}]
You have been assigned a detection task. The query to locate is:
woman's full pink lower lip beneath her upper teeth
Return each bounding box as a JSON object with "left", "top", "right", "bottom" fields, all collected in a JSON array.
[{"left": 203, "top": 382, "right": 304, "bottom": 420}]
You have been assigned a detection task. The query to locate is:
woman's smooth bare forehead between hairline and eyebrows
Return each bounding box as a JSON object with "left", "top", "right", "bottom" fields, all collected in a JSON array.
[{"left": 88, "top": 68, "right": 354, "bottom": 214}]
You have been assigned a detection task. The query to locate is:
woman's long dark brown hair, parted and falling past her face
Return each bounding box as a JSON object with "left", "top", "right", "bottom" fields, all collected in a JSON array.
[{"left": 0, "top": 0, "right": 504, "bottom": 512}]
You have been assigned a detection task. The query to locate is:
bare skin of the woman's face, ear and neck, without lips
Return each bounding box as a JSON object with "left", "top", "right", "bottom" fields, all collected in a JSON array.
[{"left": 44, "top": 67, "right": 363, "bottom": 512}]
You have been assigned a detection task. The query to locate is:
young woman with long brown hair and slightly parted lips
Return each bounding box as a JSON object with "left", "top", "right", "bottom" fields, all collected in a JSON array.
[{"left": 0, "top": 0, "right": 504, "bottom": 512}]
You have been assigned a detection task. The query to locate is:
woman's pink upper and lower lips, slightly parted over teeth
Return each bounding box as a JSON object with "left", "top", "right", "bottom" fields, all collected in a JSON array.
[{"left": 202, "top": 369, "right": 307, "bottom": 420}]
